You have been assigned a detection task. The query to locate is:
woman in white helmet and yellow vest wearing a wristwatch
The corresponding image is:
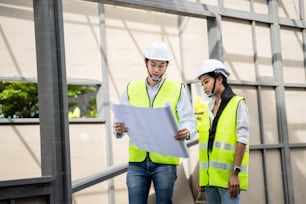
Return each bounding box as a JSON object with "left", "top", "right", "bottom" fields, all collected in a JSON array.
[{"left": 197, "top": 59, "right": 249, "bottom": 204}]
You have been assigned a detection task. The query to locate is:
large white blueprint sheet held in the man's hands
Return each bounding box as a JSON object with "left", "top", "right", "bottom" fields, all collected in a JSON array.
[{"left": 112, "top": 104, "right": 189, "bottom": 158}]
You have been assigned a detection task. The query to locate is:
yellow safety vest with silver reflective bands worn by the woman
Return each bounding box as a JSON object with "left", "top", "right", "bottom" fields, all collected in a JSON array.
[{"left": 199, "top": 96, "right": 249, "bottom": 190}]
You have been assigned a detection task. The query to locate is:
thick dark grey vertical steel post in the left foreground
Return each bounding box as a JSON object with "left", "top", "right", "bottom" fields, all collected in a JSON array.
[{"left": 33, "top": 0, "right": 72, "bottom": 204}]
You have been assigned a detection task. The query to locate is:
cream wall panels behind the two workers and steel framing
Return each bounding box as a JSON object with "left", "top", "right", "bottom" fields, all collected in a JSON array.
[{"left": 0, "top": 0, "right": 306, "bottom": 204}]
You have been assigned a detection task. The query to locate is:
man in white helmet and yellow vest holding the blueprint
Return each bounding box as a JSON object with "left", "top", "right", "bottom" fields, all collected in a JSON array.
[{"left": 114, "top": 41, "right": 196, "bottom": 204}]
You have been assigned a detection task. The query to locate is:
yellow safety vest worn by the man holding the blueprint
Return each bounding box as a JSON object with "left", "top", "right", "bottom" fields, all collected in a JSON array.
[{"left": 127, "top": 79, "right": 183, "bottom": 165}]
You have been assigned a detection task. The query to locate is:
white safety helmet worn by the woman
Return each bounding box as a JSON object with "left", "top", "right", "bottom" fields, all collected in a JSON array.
[{"left": 196, "top": 59, "right": 230, "bottom": 79}]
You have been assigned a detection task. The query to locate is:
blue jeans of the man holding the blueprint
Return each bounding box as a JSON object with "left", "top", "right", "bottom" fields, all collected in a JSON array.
[{"left": 126, "top": 157, "right": 176, "bottom": 204}]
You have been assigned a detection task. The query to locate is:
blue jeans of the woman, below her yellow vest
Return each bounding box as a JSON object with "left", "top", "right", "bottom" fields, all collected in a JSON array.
[{"left": 205, "top": 186, "right": 240, "bottom": 204}]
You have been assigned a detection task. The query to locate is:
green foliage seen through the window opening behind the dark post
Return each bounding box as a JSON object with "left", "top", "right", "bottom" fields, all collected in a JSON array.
[{"left": 0, "top": 81, "right": 97, "bottom": 118}]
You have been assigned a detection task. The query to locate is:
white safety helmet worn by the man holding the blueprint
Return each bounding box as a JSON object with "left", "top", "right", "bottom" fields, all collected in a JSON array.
[{"left": 144, "top": 40, "right": 171, "bottom": 61}]
